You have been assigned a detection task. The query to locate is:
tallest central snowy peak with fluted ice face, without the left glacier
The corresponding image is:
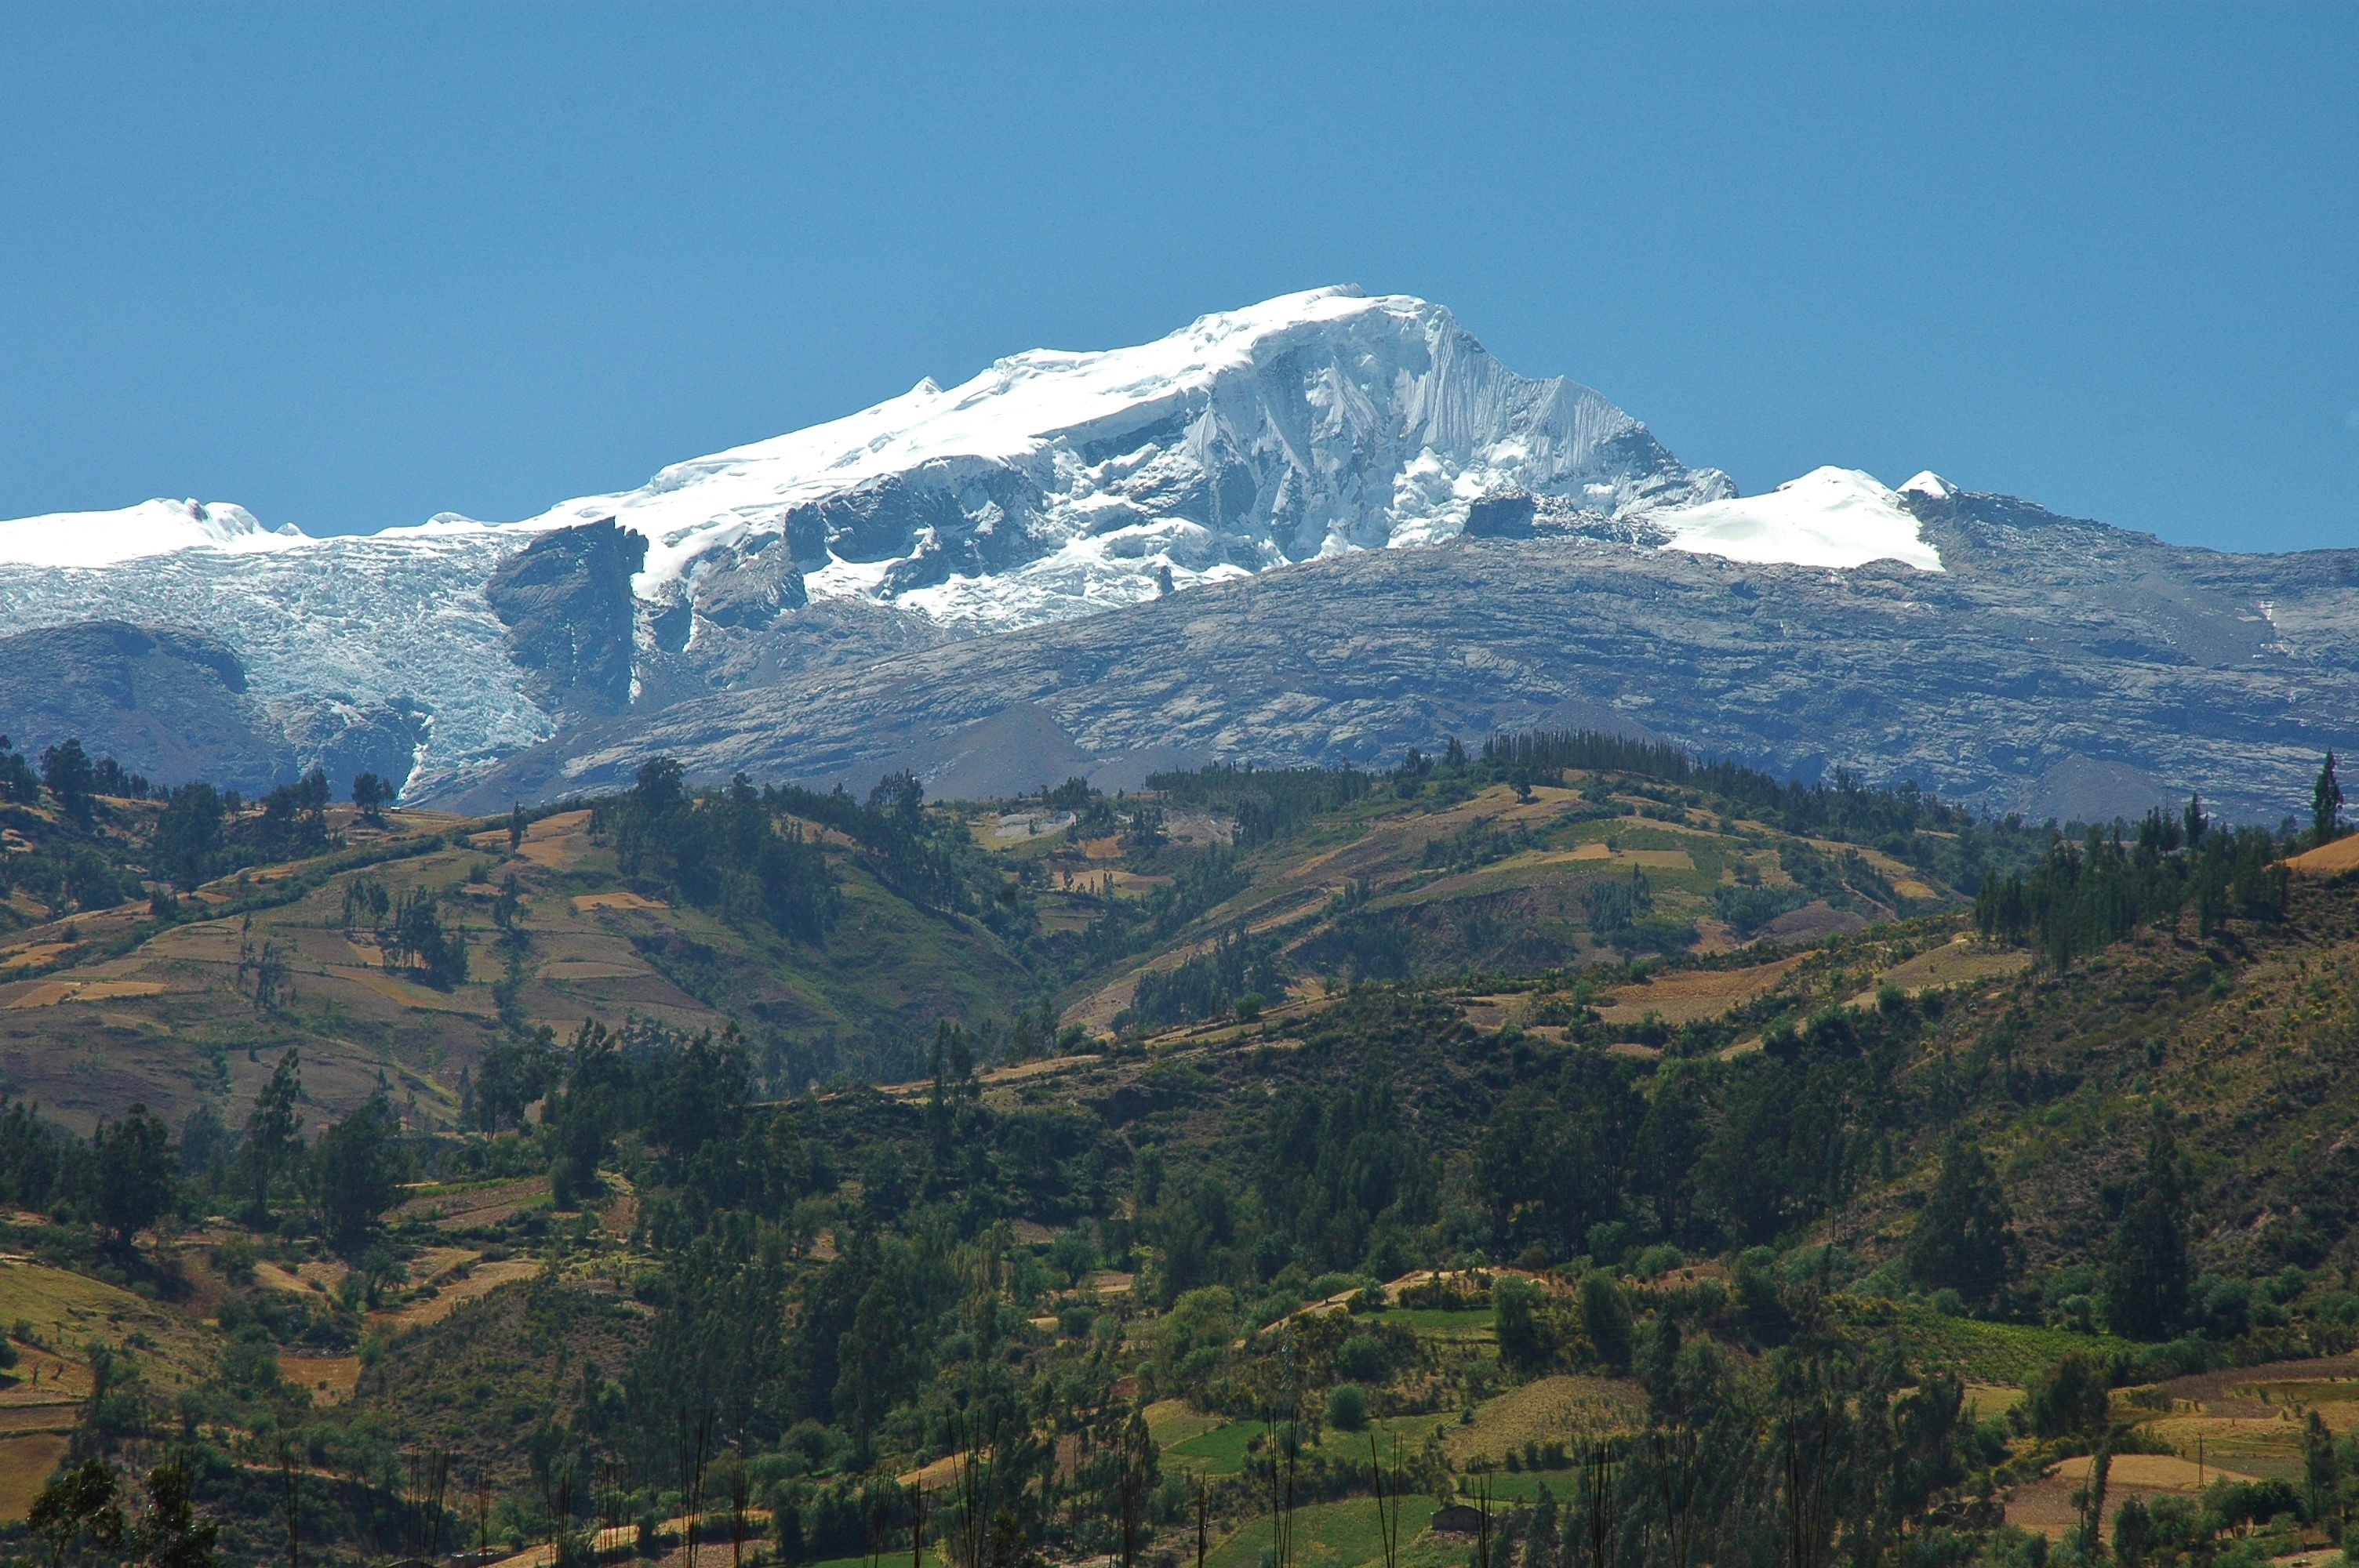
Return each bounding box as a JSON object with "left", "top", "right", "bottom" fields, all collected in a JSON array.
[{"left": 507, "top": 288, "right": 1734, "bottom": 630}]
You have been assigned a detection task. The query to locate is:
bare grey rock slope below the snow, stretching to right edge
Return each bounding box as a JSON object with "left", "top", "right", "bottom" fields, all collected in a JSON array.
[{"left": 443, "top": 493, "right": 2359, "bottom": 823}]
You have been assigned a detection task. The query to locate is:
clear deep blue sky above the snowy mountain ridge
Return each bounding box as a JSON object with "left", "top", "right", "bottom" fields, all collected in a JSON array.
[{"left": 0, "top": 5, "right": 2359, "bottom": 550}]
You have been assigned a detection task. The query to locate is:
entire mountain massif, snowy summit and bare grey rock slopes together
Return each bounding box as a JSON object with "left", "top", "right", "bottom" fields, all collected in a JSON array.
[{"left": 0, "top": 290, "right": 2359, "bottom": 816}]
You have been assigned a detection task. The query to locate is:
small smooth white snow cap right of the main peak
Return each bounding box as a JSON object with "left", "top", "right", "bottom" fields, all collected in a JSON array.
[{"left": 1647, "top": 466, "right": 1942, "bottom": 571}]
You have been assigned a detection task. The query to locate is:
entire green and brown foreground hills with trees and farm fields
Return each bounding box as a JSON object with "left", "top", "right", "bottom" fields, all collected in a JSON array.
[{"left": 0, "top": 735, "right": 2359, "bottom": 1568}]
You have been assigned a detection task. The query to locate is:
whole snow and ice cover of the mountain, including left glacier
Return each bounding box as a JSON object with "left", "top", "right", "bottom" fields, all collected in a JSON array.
[{"left": 0, "top": 288, "right": 1942, "bottom": 800}]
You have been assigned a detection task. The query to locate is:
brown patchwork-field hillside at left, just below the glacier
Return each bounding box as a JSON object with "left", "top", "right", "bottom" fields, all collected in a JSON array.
[{"left": 0, "top": 814, "right": 1028, "bottom": 1132}]
